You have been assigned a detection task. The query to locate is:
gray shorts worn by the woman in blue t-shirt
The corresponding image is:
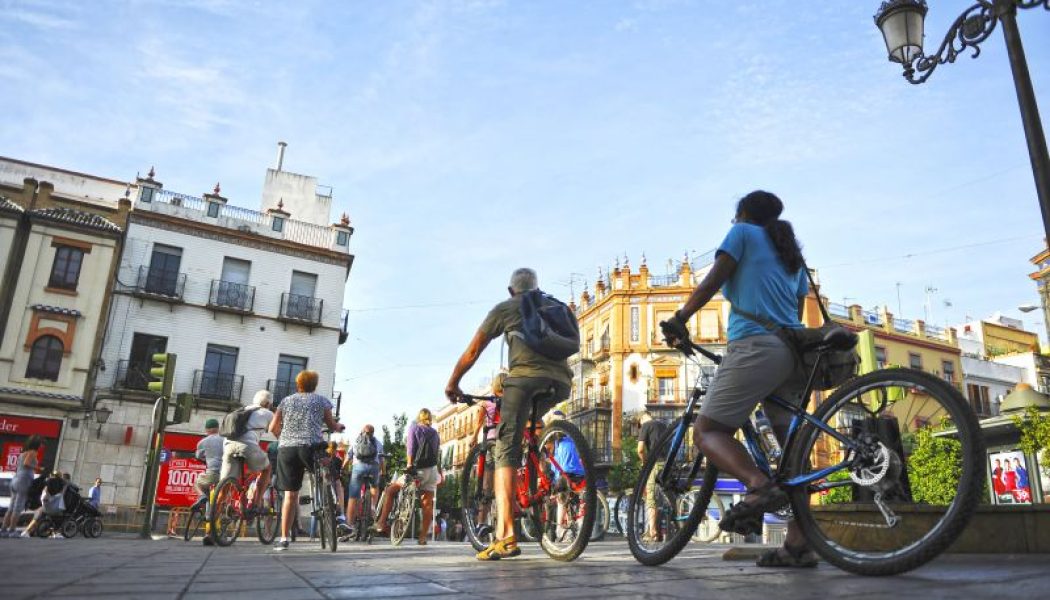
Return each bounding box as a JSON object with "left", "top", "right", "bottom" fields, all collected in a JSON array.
[{"left": 700, "top": 334, "right": 805, "bottom": 431}]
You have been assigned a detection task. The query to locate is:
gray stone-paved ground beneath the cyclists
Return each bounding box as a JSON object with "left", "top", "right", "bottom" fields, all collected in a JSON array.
[{"left": 0, "top": 536, "right": 1050, "bottom": 600}]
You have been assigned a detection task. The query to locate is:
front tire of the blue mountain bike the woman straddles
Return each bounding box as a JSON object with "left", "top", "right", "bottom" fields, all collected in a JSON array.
[{"left": 625, "top": 417, "right": 718, "bottom": 566}]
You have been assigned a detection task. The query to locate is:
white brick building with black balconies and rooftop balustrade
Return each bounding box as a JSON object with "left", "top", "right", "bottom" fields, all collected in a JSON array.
[{"left": 91, "top": 157, "right": 354, "bottom": 505}]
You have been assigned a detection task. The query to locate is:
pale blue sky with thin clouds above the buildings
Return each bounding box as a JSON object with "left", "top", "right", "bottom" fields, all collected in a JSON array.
[{"left": 0, "top": 0, "right": 1050, "bottom": 427}]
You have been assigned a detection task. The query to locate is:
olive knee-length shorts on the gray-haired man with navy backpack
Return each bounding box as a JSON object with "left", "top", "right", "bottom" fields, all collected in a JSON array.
[{"left": 492, "top": 377, "right": 569, "bottom": 469}]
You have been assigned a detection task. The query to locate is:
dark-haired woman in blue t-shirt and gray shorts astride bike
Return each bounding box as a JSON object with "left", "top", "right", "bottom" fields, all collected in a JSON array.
[{"left": 662, "top": 191, "right": 816, "bottom": 566}]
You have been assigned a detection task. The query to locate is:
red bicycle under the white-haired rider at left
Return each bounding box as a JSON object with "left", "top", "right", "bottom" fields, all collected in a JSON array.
[{"left": 208, "top": 456, "right": 280, "bottom": 546}]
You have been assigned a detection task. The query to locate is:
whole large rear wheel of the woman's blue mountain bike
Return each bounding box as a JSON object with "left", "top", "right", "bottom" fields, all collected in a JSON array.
[{"left": 785, "top": 369, "right": 985, "bottom": 575}]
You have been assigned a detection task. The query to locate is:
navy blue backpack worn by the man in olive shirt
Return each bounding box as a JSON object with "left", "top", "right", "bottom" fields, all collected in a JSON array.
[{"left": 507, "top": 290, "right": 580, "bottom": 360}]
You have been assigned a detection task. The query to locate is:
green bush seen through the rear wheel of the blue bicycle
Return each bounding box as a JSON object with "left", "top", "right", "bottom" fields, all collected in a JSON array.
[{"left": 907, "top": 427, "right": 963, "bottom": 504}]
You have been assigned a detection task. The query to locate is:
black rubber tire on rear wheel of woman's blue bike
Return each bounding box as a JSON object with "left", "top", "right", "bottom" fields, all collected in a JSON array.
[{"left": 786, "top": 368, "right": 985, "bottom": 576}]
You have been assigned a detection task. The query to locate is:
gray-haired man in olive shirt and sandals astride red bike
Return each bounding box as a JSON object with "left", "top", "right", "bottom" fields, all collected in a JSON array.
[{"left": 445, "top": 269, "right": 572, "bottom": 560}]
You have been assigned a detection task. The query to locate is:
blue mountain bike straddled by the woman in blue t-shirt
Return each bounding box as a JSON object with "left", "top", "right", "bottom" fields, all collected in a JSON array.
[{"left": 627, "top": 328, "right": 984, "bottom": 575}]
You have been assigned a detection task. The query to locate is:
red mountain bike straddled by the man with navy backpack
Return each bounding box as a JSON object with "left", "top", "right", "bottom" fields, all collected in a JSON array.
[{"left": 458, "top": 394, "right": 597, "bottom": 561}]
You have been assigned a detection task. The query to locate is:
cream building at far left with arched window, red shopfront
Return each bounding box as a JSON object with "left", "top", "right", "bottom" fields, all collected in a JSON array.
[{"left": 0, "top": 158, "right": 131, "bottom": 485}]
